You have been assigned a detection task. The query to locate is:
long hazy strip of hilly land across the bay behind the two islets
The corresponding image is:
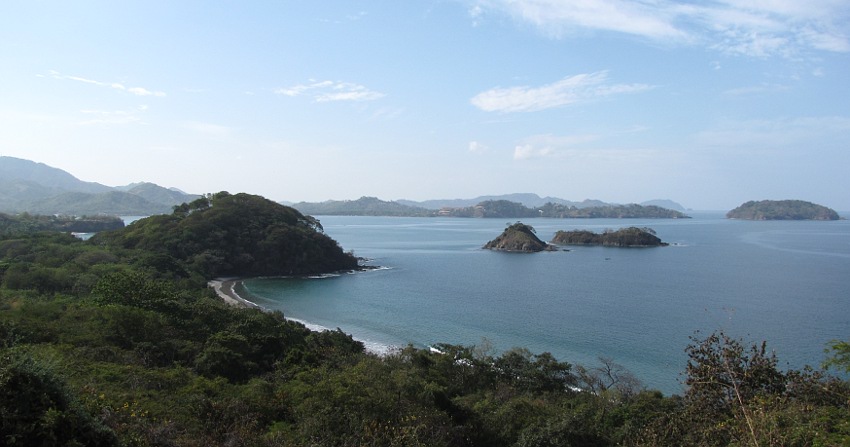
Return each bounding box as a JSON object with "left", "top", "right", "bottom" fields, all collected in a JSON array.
[{"left": 292, "top": 197, "right": 689, "bottom": 219}]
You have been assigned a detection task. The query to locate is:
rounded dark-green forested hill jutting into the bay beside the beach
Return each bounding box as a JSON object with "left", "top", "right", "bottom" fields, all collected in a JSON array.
[{"left": 93, "top": 192, "right": 357, "bottom": 278}]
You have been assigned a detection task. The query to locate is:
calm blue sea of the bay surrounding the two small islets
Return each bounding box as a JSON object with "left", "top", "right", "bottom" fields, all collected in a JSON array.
[{"left": 243, "top": 213, "right": 850, "bottom": 394}]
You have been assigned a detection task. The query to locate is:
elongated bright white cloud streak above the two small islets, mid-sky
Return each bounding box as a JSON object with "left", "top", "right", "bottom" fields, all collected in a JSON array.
[{"left": 470, "top": 71, "right": 652, "bottom": 112}]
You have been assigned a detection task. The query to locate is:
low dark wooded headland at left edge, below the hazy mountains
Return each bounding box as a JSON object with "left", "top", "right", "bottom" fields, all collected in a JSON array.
[{"left": 0, "top": 213, "right": 124, "bottom": 236}]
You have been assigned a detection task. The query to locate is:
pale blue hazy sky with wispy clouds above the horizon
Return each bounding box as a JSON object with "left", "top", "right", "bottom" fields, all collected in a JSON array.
[{"left": 0, "top": 0, "right": 850, "bottom": 210}]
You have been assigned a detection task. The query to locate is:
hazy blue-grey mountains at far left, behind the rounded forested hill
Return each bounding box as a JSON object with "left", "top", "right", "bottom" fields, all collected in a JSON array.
[{"left": 0, "top": 156, "right": 200, "bottom": 216}]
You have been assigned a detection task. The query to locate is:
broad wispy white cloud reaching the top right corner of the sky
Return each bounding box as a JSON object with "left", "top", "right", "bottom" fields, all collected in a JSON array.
[{"left": 470, "top": 0, "right": 850, "bottom": 58}]
